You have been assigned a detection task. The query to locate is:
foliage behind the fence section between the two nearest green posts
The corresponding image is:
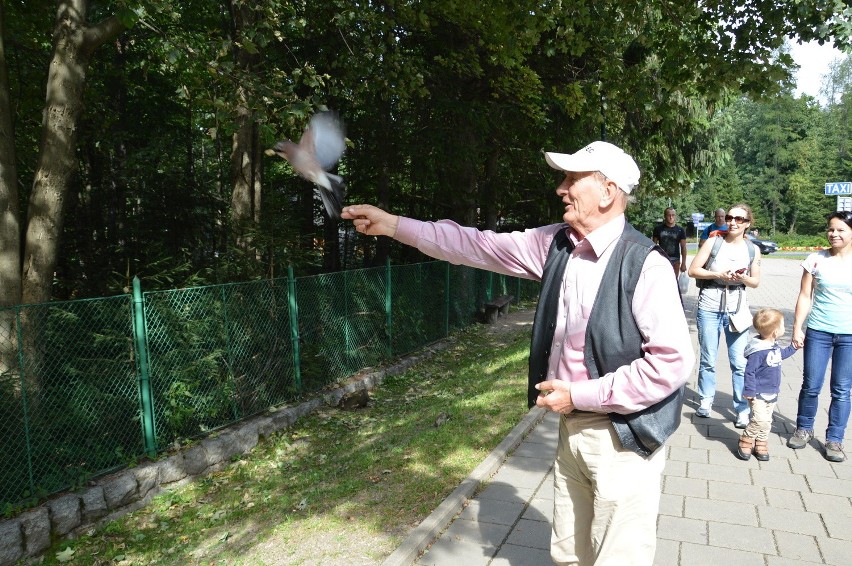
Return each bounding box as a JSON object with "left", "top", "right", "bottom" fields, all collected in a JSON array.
[{"left": 146, "top": 280, "right": 298, "bottom": 447}]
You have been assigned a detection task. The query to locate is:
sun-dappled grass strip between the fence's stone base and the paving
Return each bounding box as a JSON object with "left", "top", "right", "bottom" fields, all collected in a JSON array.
[{"left": 43, "top": 312, "right": 529, "bottom": 566}]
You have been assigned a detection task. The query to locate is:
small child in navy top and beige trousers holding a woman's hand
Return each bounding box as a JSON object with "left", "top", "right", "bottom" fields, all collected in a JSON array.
[{"left": 737, "top": 309, "right": 796, "bottom": 462}]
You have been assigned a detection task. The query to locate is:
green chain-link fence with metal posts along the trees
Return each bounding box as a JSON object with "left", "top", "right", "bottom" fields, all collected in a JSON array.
[{"left": 0, "top": 261, "right": 539, "bottom": 514}]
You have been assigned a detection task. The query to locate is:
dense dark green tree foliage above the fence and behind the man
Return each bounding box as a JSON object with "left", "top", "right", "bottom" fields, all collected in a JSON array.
[{"left": 2, "top": 0, "right": 850, "bottom": 298}]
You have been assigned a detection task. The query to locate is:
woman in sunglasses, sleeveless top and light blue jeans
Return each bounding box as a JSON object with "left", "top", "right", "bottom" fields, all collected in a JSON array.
[{"left": 689, "top": 203, "right": 760, "bottom": 428}]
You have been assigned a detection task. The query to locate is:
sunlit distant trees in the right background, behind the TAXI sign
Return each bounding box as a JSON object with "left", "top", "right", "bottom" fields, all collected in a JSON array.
[{"left": 695, "top": 52, "right": 852, "bottom": 237}]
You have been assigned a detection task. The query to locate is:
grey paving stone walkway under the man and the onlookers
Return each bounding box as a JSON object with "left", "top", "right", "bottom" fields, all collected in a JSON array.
[{"left": 392, "top": 257, "right": 852, "bottom": 566}]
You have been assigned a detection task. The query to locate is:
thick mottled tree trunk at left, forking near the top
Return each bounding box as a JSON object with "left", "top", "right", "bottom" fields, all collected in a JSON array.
[{"left": 21, "top": 0, "right": 125, "bottom": 303}]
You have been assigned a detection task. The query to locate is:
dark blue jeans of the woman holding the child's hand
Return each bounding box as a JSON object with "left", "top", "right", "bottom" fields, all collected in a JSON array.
[{"left": 796, "top": 328, "right": 852, "bottom": 442}]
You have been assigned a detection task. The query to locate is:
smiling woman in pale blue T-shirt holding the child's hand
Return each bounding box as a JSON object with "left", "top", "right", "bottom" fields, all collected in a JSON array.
[{"left": 787, "top": 212, "right": 852, "bottom": 462}]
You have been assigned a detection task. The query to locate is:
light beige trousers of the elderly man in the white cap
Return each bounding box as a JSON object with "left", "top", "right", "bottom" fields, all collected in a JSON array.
[{"left": 550, "top": 413, "right": 665, "bottom": 566}]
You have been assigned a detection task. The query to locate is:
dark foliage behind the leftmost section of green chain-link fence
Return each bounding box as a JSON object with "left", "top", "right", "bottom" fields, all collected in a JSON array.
[{"left": 0, "top": 297, "right": 142, "bottom": 505}]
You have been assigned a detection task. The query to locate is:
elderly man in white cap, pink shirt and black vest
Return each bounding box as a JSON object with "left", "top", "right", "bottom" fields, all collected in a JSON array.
[{"left": 342, "top": 142, "right": 694, "bottom": 566}]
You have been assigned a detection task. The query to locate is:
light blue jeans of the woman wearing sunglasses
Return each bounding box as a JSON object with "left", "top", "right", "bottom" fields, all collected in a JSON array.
[{"left": 695, "top": 309, "right": 748, "bottom": 414}]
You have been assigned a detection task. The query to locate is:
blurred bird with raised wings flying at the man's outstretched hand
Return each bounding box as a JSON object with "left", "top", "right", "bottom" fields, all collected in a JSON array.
[{"left": 267, "top": 111, "right": 346, "bottom": 219}]
